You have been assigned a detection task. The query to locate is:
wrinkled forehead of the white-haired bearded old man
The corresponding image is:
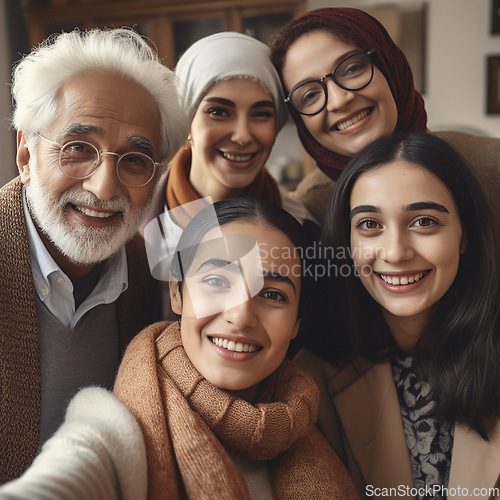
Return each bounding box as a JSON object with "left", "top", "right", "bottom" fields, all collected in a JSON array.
[{"left": 49, "top": 72, "right": 161, "bottom": 150}]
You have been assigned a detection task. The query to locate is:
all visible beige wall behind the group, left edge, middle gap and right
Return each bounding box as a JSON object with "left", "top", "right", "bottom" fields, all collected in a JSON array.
[{"left": 0, "top": 0, "right": 500, "bottom": 185}]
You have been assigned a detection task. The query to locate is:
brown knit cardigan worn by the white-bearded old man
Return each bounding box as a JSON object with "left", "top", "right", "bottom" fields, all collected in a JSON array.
[{"left": 0, "top": 178, "right": 160, "bottom": 484}]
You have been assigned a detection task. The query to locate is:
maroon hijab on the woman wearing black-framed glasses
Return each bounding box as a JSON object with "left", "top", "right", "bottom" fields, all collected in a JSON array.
[{"left": 282, "top": 8, "right": 427, "bottom": 180}]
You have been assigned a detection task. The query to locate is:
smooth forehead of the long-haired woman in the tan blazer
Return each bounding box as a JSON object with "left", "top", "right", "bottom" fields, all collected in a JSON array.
[{"left": 350, "top": 161, "right": 455, "bottom": 210}]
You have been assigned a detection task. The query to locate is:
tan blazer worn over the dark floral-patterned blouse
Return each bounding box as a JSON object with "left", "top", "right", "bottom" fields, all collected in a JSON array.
[{"left": 295, "top": 350, "right": 500, "bottom": 500}]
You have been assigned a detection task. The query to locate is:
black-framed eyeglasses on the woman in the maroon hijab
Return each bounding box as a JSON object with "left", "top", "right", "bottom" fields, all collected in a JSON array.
[{"left": 285, "top": 50, "right": 374, "bottom": 116}]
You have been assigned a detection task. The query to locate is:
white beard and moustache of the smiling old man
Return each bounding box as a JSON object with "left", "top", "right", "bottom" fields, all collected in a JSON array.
[{"left": 26, "top": 162, "right": 152, "bottom": 265}]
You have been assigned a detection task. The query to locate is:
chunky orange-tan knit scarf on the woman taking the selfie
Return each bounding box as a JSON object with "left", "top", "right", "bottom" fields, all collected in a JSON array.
[{"left": 115, "top": 322, "right": 358, "bottom": 500}]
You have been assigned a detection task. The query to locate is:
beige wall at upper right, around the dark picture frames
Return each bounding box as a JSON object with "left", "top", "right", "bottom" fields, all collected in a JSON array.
[{"left": 309, "top": 0, "right": 500, "bottom": 137}]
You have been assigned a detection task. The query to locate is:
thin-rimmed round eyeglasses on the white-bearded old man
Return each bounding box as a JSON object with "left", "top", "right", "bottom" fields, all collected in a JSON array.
[{"left": 37, "top": 134, "right": 161, "bottom": 187}]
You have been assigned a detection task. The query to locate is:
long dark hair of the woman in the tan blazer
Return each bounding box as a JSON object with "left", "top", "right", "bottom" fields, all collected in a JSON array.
[{"left": 318, "top": 133, "right": 500, "bottom": 439}]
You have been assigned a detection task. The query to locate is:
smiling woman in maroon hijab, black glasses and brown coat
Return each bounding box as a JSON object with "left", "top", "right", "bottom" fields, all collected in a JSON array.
[{"left": 271, "top": 8, "right": 500, "bottom": 222}]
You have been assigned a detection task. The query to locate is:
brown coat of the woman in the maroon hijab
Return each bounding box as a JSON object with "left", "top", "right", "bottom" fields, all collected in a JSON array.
[{"left": 296, "top": 131, "right": 500, "bottom": 224}]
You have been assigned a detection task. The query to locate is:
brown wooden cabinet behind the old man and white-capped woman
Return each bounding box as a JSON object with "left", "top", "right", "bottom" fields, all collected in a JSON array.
[{"left": 27, "top": 0, "right": 306, "bottom": 68}]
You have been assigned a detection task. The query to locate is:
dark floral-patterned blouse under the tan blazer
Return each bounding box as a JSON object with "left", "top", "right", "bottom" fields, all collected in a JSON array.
[{"left": 392, "top": 353, "right": 454, "bottom": 500}]
